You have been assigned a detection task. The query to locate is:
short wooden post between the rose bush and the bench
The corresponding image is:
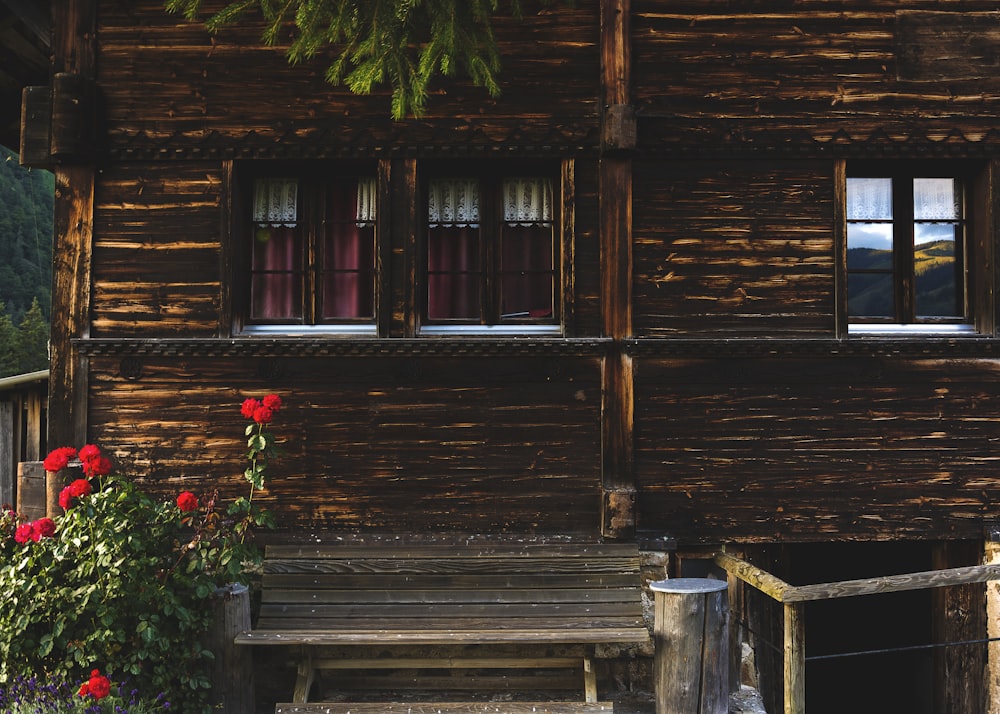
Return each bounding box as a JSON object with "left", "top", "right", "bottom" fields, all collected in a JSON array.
[{"left": 211, "top": 584, "right": 255, "bottom": 714}]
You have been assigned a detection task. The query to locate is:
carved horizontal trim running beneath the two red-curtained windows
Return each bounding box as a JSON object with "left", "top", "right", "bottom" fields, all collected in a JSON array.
[{"left": 73, "top": 338, "right": 613, "bottom": 360}]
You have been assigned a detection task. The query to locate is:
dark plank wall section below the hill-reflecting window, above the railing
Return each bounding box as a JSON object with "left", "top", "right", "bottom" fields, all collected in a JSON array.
[{"left": 636, "top": 354, "right": 1000, "bottom": 541}]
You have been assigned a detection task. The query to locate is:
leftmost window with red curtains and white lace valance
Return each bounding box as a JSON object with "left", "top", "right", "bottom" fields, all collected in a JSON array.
[{"left": 246, "top": 175, "right": 376, "bottom": 331}]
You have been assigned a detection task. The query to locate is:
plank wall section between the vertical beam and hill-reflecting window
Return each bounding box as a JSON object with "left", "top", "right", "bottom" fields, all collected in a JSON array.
[{"left": 632, "top": 161, "right": 836, "bottom": 338}]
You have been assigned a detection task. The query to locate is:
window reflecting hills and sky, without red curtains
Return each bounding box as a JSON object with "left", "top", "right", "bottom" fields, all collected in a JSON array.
[{"left": 847, "top": 165, "right": 972, "bottom": 329}]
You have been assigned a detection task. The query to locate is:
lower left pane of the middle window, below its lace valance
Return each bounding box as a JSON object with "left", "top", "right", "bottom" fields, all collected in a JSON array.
[{"left": 427, "top": 226, "right": 481, "bottom": 320}]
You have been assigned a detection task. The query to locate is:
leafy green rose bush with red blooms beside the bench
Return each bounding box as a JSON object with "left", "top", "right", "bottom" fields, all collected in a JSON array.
[{"left": 0, "top": 395, "right": 281, "bottom": 713}]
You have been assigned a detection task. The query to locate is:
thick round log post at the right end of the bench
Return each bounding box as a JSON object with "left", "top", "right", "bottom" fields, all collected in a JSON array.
[{"left": 650, "top": 578, "right": 729, "bottom": 714}]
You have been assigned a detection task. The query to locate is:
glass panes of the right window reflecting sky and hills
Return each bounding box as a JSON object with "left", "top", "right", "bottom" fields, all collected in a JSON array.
[{"left": 847, "top": 178, "right": 963, "bottom": 322}]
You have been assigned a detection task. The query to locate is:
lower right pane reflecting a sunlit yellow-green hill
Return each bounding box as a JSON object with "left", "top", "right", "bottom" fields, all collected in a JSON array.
[{"left": 913, "top": 223, "right": 963, "bottom": 317}]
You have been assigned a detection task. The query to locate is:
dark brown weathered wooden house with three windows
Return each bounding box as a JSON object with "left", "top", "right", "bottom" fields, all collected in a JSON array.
[{"left": 15, "top": 0, "right": 1000, "bottom": 712}]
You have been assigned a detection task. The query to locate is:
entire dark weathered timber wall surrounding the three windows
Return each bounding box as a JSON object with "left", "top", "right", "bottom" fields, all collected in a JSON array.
[{"left": 35, "top": 0, "right": 1000, "bottom": 543}]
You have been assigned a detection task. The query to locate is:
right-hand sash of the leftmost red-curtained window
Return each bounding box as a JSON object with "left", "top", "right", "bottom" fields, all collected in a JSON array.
[{"left": 318, "top": 179, "right": 375, "bottom": 320}]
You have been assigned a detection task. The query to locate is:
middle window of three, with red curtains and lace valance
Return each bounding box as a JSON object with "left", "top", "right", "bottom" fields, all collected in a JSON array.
[{"left": 422, "top": 173, "right": 560, "bottom": 331}]
